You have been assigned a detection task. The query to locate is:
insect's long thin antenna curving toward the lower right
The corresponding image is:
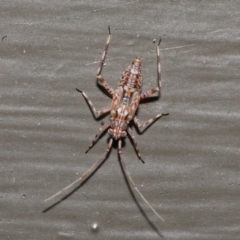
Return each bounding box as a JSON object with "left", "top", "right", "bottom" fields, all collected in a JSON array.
[{"left": 118, "top": 140, "right": 165, "bottom": 222}]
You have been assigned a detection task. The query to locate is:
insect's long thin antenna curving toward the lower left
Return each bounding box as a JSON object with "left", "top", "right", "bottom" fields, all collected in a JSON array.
[{"left": 44, "top": 139, "right": 113, "bottom": 202}]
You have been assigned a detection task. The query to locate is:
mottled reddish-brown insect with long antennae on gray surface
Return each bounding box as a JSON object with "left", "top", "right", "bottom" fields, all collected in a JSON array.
[{"left": 45, "top": 27, "right": 168, "bottom": 221}]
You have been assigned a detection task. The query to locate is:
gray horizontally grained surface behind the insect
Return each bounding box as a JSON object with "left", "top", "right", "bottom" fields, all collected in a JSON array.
[{"left": 0, "top": 0, "right": 240, "bottom": 240}]
